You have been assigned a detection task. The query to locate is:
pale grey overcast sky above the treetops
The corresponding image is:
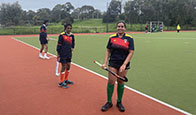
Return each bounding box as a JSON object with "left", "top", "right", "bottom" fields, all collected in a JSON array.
[{"left": 0, "top": 0, "right": 111, "bottom": 12}]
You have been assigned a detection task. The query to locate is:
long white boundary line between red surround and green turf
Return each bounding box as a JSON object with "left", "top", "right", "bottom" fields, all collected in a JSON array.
[{"left": 12, "top": 37, "right": 192, "bottom": 115}]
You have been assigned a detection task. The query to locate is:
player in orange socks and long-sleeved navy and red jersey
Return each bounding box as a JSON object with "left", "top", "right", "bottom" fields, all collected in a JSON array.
[{"left": 57, "top": 24, "right": 75, "bottom": 88}]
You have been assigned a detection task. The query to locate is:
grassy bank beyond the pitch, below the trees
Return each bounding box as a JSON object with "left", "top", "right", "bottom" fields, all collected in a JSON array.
[{"left": 0, "top": 19, "right": 187, "bottom": 35}]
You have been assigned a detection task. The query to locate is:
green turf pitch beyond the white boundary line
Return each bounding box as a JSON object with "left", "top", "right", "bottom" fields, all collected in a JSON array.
[{"left": 14, "top": 32, "right": 196, "bottom": 114}]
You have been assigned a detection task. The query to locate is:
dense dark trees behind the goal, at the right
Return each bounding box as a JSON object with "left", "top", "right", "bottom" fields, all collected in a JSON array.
[{"left": 124, "top": 0, "right": 196, "bottom": 26}]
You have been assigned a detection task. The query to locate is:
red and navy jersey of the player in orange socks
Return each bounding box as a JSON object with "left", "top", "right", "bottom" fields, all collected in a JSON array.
[{"left": 57, "top": 32, "right": 75, "bottom": 59}]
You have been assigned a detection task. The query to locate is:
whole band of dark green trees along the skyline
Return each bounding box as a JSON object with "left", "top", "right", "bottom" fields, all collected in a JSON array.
[{"left": 0, "top": 0, "right": 196, "bottom": 26}]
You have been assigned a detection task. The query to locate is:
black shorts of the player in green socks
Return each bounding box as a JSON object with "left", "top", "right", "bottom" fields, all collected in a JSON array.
[{"left": 108, "top": 60, "right": 130, "bottom": 70}]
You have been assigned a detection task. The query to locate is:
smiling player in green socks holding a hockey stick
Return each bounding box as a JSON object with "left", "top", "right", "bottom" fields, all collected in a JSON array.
[{"left": 101, "top": 21, "right": 134, "bottom": 112}]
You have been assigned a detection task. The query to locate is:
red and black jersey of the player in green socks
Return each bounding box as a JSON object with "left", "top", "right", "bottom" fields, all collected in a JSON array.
[{"left": 107, "top": 34, "right": 134, "bottom": 61}]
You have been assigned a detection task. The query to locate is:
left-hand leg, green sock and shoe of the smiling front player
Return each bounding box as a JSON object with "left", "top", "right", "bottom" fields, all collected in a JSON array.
[{"left": 101, "top": 67, "right": 117, "bottom": 111}]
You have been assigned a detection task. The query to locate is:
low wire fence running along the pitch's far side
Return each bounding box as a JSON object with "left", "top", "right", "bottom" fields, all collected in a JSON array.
[{"left": 0, "top": 24, "right": 196, "bottom": 35}]
